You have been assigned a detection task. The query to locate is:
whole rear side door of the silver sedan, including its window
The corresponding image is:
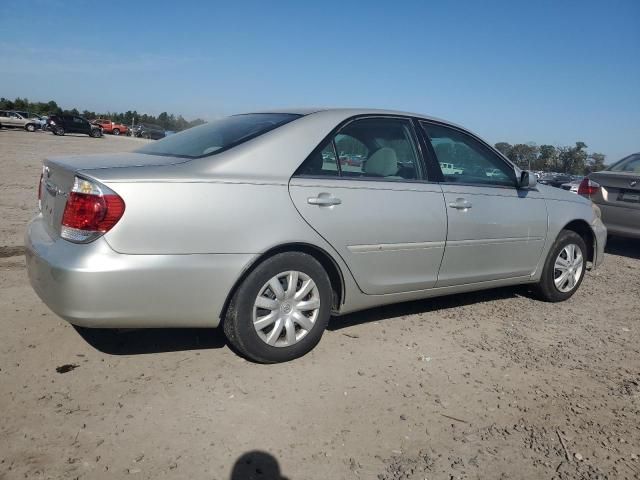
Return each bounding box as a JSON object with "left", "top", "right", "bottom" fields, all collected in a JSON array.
[{"left": 289, "top": 117, "right": 447, "bottom": 294}]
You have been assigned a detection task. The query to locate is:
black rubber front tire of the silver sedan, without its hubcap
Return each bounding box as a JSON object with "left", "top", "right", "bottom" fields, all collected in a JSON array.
[{"left": 534, "top": 230, "right": 588, "bottom": 302}]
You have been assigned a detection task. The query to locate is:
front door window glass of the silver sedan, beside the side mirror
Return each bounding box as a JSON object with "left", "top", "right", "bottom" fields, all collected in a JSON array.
[{"left": 421, "top": 122, "right": 515, "bottom": 187}]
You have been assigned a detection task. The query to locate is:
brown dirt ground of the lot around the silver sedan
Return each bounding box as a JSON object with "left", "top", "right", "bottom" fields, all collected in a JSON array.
[{"left": 0, "top": 130, "right": 640, "bottom": 480}]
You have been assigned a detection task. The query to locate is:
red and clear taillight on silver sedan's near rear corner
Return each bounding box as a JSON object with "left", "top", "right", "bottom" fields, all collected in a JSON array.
[{"left": 60, "top": 177, "right": 124, "bottom": 243}]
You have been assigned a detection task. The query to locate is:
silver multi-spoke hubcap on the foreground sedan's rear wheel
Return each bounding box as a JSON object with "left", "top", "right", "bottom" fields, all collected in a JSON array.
[{"left": 253, "top": 271, "right": 320, "bottom": 347}]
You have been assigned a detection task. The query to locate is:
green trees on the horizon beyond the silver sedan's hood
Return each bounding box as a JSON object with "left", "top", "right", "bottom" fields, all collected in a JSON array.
[{"left": 494, "top": 142, "right": 606, "bottom": 175}]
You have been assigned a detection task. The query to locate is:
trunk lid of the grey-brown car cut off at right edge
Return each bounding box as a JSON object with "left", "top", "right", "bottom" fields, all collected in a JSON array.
[{"left": 589, "top": 170, "right": 640, "bottom": 209}]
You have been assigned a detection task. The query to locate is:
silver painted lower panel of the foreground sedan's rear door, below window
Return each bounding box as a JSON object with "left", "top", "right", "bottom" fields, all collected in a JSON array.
[{"left": 289, "top": 178, "right": 447, "bottom": 294}]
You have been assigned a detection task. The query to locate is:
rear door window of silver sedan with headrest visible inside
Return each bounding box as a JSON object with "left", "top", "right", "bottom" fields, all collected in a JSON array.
[{"left": 296, "top": 118, "right": 419, "bottom": 181}]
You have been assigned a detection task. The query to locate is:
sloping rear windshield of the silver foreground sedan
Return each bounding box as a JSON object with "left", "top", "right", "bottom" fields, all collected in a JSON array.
[{"left": 137, "top": 113, "right": 301, "bottom": 158}]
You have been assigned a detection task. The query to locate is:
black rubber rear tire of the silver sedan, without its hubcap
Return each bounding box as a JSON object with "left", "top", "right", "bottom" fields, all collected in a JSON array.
[{"left": 223, "top": 252, "right": 332, "bottom": 363}]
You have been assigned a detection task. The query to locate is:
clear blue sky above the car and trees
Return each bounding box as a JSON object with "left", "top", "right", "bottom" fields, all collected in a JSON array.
[{"left": 0, "top": 0, "right": 640, "bottom": 162}]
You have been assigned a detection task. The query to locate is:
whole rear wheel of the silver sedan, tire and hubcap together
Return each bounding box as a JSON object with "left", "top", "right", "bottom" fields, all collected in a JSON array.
[{"left": 223, "top": 252, "right": 332, "bottom": 363}]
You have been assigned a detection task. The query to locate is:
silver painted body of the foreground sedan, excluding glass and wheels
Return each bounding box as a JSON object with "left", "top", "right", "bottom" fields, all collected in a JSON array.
[{"left": 25, "top": 110, "right": 606, "bottom": 327}]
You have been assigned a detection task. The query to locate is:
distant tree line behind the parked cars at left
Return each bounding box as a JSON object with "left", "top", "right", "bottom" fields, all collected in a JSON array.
[{"left": 0, "top": 97, "right": 205, "bottom": 132}]
